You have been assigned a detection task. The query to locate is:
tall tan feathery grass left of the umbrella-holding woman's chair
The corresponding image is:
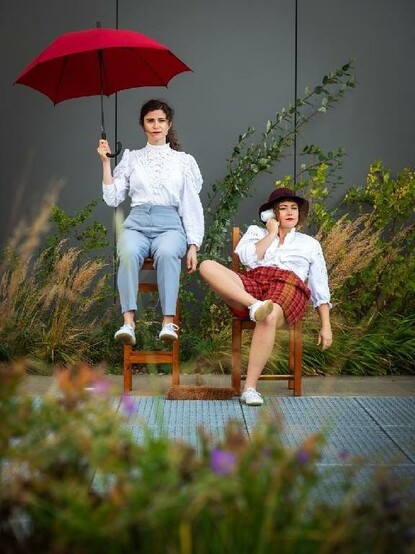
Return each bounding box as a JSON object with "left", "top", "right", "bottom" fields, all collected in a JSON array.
[{"left": 0, "top": 193, "right": 112, "bottom": 364}]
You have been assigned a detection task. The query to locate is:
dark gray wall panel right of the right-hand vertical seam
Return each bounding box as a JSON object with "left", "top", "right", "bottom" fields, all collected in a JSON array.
[{"left": 298, "top": 0, "right": 415, "bottom": 202}]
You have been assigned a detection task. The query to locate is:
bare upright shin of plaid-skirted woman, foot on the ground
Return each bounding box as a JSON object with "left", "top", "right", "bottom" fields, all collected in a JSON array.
[{"left": 245, "top": 304, "right": 285, "bottom": 389}]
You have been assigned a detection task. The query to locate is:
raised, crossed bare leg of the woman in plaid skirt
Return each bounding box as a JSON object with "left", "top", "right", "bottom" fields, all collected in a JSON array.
[{"left": 199, "top": 260, "right": 257, "bottom": 310}]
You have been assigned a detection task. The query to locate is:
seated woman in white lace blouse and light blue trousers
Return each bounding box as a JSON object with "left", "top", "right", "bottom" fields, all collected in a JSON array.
[{"left": 97, "top": 100, "right": 204, "bottom": 345}]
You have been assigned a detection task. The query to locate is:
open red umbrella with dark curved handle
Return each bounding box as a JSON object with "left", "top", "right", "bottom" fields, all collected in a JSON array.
[{"left": 16, "top": 23, "right": 191, "bottom": 157}]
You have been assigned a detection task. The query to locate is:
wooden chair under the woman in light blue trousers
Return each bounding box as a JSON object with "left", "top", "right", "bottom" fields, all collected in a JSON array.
[{"left": 124, "top": 258, "right": 180, "bottom": 392}]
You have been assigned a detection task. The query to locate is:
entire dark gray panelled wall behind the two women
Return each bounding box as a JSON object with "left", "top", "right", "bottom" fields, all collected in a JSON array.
[{"left": 0, "top": 0, "right": 415, "bottom": 246}]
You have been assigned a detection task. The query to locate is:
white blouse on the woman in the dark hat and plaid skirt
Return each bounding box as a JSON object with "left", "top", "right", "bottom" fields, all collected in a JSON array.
[{"left": 235, "top": 225, "right": 331, "bottom": 308}]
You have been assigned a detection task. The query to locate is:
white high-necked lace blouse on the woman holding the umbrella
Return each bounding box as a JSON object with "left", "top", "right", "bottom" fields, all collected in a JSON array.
[{"left": 102, "top": 143, "right": 204, "bottom": 248}]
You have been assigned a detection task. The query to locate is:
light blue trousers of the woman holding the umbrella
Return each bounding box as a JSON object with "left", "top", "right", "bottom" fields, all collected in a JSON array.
[{"left": 117, "top": 204, "right": 187, "bottom": 315}]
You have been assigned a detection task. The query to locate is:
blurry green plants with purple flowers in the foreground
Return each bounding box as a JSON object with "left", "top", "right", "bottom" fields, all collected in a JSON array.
[{"left": 0, "top": 366, "right": 414, "bottom": 554}]
